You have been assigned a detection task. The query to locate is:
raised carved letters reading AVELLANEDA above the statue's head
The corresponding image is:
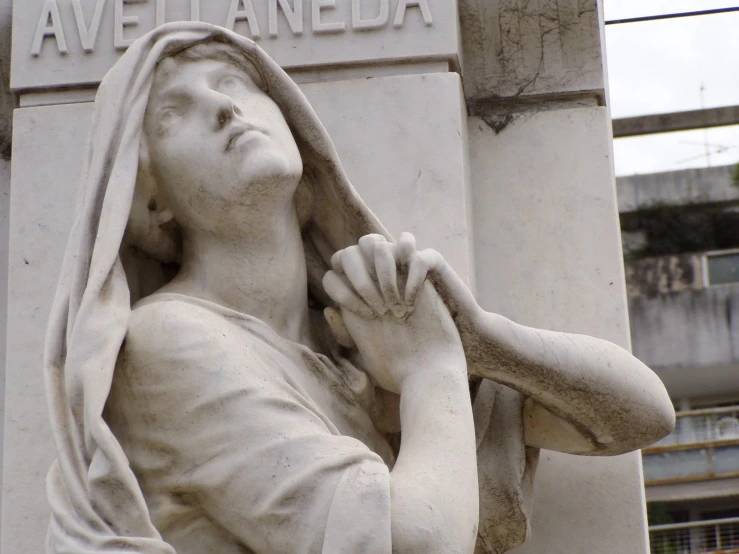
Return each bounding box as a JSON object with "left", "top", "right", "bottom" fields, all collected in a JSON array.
[{"left": 31, "top": 0, "right": 434, "bottom": 56}]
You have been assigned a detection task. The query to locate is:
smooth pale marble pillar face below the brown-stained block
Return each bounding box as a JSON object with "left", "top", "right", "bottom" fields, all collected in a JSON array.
[{"left": 469, "top": 108, "right": 648, "bottom": 554}]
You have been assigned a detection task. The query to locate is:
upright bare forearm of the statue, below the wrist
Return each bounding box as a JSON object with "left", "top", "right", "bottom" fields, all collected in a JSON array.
[{"left": 390, "top": 361, "right": 479, "bottom": 554}]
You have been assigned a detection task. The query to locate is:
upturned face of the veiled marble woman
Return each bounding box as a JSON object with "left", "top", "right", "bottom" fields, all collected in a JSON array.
[{"left": 144, "top": 54, "right": 303, "bottom": 231}]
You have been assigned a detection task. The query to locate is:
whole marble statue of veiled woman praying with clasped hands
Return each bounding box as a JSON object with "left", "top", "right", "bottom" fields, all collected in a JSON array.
[{"left": 45, "top": 23, "right": 674, "bottom": 554}]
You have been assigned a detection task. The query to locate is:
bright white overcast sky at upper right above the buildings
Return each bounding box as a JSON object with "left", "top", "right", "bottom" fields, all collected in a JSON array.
[{"left": 605, "top": 0, "right": 739, "bottom": 175}]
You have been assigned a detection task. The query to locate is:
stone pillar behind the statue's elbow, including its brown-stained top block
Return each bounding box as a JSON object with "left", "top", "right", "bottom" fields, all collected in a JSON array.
[{"left": 460, "top": 0, "right": 648, "bottom": 554}]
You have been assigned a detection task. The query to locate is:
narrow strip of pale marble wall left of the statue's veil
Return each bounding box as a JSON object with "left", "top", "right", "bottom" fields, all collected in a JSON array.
[{"left": 0, "top": 101, "right": 91, "bottom": 552}]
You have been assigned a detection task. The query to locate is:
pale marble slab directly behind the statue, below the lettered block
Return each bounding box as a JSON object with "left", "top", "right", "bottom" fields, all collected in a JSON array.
[{"left": 0, "top": 38, "right": 472, "bottom": 552}]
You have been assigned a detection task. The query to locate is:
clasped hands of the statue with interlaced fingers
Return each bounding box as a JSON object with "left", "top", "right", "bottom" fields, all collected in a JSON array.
[{"left": 323, "top": 233, "right": 466, "bottom": 393}]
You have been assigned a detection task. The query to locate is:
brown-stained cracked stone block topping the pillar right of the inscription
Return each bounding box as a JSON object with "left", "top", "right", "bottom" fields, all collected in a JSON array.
[{"left": 459, "top": 0, "right": 606, "bottom": 101}]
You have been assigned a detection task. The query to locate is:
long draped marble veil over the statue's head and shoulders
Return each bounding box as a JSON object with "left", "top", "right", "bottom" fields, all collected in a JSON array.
[{"left": 44, "top": 23, "right": 535, "bottom": 554}]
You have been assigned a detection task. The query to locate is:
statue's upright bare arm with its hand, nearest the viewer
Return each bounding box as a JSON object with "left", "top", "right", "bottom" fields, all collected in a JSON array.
[{"left": 324, "top": 251, "right": 479, "bottom": 554}]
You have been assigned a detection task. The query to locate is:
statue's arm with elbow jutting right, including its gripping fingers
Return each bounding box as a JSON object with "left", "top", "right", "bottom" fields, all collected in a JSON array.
[{"left": 326, "top": 234, "right": 674, "bottom": 455}]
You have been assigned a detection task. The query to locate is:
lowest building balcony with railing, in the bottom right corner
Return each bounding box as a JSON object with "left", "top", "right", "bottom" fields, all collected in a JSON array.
[{"left": 649, "top": 518, "right": 739, "bottom": 554}]
